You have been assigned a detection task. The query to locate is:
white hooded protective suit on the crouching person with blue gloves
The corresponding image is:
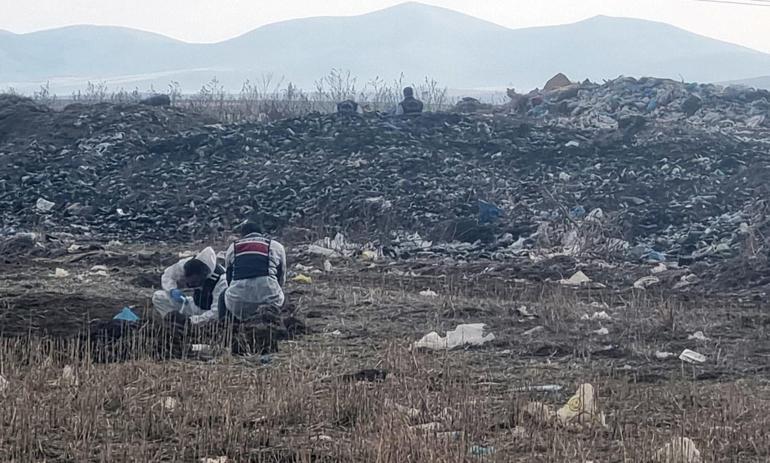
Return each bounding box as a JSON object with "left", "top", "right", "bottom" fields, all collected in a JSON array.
[{"left": 152, "top": 247, "right": 227, "bottom": 324}]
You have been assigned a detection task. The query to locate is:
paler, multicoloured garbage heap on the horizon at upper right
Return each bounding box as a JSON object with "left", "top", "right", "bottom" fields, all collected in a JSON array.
[{"left": 509, "top": 74, "right": 770, "bottom": 138}]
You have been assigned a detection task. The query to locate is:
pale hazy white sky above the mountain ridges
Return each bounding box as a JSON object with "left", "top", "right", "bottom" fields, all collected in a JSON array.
[{"left": 0, "top": 0, "right": 770, "bottom": 53}]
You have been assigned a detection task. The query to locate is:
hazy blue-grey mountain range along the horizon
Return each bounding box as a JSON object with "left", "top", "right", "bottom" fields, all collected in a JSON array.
[{"left": 0, "top": 2, "right": 770, "bottom": 92}]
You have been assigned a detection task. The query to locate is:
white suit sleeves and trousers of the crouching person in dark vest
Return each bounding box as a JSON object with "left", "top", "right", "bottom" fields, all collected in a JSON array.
[{"left": 225, "top": 235, "right": 286, "bottom": 320}]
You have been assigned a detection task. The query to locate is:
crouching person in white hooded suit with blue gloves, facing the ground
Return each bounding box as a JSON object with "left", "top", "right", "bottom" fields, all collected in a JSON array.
[{"left": 152, "top": 247, "right": 227, "bottom": 324}]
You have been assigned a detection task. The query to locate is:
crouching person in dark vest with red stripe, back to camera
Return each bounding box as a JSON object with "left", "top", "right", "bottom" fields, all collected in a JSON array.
[{"left": 220, "top": 222, "right": 286, "bottom": 322}]
